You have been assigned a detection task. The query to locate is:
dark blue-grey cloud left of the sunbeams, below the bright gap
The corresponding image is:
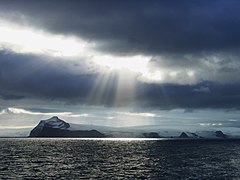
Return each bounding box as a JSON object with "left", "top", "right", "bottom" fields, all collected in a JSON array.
[{"left": 0, "top": 51, "right": 94, "bottom": 99}]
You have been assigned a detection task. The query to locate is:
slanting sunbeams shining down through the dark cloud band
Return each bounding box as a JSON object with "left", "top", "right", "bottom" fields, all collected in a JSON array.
[{"left": 87, "top": 70, "right": 137, "bottom": 106}]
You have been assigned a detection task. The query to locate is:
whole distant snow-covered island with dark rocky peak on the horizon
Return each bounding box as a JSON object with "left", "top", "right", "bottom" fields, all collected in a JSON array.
[{"left": 29, "top": 116, "right": 229, "bottom": 139}]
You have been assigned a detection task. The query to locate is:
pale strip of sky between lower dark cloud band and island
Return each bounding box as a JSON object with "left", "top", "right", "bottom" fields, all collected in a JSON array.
[{"left": 0, "top": 106, "right": 240, "bottom": 129}]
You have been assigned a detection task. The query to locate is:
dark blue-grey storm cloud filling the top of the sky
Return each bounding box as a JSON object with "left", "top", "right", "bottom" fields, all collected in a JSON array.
[{"left": 0, "top": 0, "right": 240, "bottom": 55}]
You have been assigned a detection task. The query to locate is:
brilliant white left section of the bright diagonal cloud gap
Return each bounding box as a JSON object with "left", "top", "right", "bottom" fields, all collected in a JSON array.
[{"left": 0, "top": 20, "right": 86, "bottom": 57}]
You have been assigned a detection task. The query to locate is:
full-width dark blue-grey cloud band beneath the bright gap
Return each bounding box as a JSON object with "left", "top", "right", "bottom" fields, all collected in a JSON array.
[{"left": 0, "top": 51, "right": 240, "bottom": 109}]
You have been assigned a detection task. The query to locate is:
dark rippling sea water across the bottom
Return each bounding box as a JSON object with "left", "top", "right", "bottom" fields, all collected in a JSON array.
[{"left": 0, "top": 138, "right": 240, "bottom": 179}]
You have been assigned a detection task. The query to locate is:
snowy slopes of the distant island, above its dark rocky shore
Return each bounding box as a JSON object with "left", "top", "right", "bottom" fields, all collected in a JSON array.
[{"left": 31, "top": 116, "right": 237, "bottom": 138}]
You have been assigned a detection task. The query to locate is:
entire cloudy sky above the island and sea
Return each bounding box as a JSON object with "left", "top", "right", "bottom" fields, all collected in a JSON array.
[{"left": 0, "top": 0, "right": 240, "bottom": 129}]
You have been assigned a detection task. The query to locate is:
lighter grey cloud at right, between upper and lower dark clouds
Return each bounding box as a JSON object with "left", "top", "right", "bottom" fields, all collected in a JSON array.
[{"left": 145, "top": 50, "right": 240, "bottom": 84}]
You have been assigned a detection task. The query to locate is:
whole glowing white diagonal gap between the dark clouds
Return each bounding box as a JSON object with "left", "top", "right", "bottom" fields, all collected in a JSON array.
[{"left": 0, "top": 20, "right": 196, "bottom": 84}]
